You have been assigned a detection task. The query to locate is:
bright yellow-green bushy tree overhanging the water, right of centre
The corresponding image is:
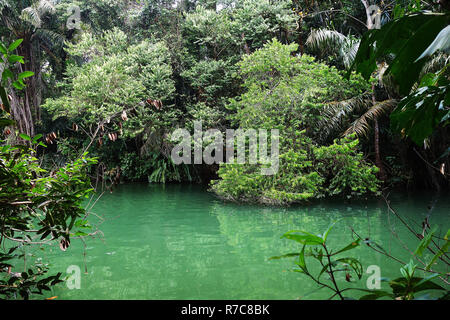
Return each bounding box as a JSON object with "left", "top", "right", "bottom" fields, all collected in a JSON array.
[{"left": 212, "top": 40, "right": 377, "bottom": 204}]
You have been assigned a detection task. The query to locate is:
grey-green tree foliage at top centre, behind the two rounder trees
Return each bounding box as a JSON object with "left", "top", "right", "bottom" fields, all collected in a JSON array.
[{"left": 180, "top": 0, "right": 295, "bottom": 122}]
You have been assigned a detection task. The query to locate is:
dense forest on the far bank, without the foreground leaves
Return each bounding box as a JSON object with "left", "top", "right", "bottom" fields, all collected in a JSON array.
[{"left": 0, "top": 0, "right": 449, "bottom": 203}]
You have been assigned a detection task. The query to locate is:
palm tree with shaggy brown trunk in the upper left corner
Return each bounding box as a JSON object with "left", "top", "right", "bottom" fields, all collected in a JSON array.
[{"left": 0, "top": 0, "right": 64, "bottom": 136}]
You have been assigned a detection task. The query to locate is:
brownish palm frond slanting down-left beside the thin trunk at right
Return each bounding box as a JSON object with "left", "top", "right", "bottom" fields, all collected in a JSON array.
[{"left": 344, "top": 99, "right": 398, "bottom": 136}]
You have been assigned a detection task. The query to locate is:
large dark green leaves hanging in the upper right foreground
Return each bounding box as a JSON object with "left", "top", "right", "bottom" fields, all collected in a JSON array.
[{"left": 354, "top": 13, "right": 450, "bottom": 145}]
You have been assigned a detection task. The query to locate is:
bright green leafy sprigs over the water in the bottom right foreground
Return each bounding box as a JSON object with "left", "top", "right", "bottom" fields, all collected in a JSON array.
[{"left": 270, "top": 222, "right": 450, "bottom": 300}]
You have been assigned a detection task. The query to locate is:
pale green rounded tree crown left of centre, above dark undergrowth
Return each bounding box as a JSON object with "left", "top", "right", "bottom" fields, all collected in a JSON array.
[{"left": 43, "top": 28, "right": 188, "bottom": 181}]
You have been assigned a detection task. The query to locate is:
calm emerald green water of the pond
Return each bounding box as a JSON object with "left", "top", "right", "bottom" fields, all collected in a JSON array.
[{"left": 34, "top": 184, "right": 450, "bottom": 300}]
